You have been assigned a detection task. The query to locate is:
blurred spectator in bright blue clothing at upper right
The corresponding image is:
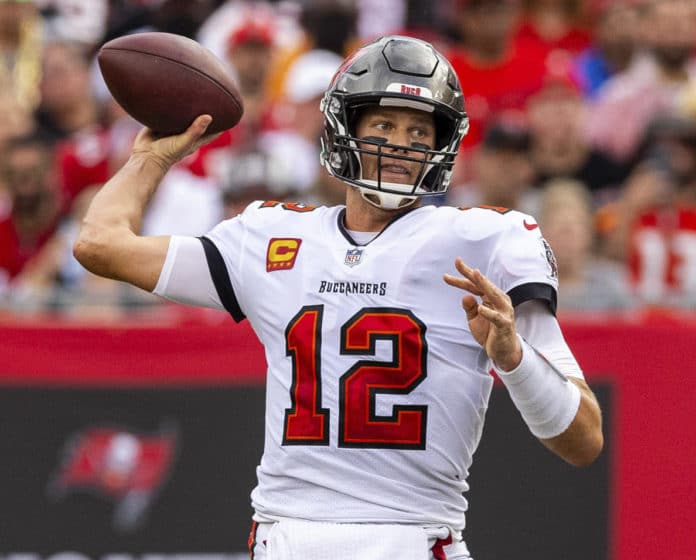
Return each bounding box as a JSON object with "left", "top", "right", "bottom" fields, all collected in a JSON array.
[{"left": 575, "top": 0, "right": 638, "bottom": 98}]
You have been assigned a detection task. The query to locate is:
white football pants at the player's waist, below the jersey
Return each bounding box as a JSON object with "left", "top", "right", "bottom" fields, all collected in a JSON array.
[{"left": 249, "top": 519, "right": 471, "bottom": 560}]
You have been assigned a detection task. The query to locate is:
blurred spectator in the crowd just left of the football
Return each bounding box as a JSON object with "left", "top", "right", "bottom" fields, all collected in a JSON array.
[{"left": 36, "top": 42, "right": 100, "bottom": 142}]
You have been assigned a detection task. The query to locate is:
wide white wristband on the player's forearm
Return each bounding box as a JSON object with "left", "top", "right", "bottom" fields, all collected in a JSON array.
[{"left": 493, "top": 335, "right": 581, "bottom": 439}]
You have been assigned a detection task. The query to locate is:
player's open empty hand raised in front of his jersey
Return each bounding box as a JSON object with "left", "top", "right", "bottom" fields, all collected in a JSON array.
[{"left": 444, "top": 257, "right": 522, "bottom": 371}]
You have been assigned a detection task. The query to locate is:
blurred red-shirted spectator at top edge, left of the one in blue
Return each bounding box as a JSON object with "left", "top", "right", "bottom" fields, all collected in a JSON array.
[{"left": 516, "top": 0, "right": 592, "bottom": 55}]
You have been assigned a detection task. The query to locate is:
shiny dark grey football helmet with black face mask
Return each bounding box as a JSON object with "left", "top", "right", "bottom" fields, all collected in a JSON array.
[{"left": 321, "top": 36, "right": 469, "bottom": 209}]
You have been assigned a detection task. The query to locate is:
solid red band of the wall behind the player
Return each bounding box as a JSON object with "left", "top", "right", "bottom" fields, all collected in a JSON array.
[{"left": 0, "top": 312, "right": 696, "bottom": 560}]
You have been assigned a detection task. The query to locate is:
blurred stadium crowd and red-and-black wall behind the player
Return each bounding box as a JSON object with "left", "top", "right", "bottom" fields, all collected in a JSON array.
[{"left": 0, "top": 0, "right": 696, "bottom": 560}]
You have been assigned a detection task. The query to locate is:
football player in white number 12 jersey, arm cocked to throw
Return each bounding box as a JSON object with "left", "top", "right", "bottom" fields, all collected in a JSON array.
[{"left": 74, "top": 36, "right": 603, "bottom": 560}]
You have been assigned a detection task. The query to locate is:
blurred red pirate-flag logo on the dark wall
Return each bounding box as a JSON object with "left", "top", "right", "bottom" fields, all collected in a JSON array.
[{"left": 48, "top": 426, "right": 178, "bottom": 533}]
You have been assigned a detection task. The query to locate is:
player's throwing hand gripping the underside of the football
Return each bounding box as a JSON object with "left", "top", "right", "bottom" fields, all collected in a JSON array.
[{"left": 131, "top": 115, "right": 220, "bottom": 171}]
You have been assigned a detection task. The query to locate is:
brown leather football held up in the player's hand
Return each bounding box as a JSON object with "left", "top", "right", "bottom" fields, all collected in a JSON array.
[{"left": 97, "top": 32, "right": 244, "bottom": 135}]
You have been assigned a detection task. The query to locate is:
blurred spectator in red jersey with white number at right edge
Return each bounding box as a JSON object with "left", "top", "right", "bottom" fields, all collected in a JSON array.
[{"left": 629, "top": 118, "right": 696, "bottom": 306}]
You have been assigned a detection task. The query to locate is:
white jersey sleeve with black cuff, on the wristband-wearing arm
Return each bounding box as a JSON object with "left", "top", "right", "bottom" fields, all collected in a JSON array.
[{"left": 488, "top": 211, "right": 558, "bottom": 314}]
